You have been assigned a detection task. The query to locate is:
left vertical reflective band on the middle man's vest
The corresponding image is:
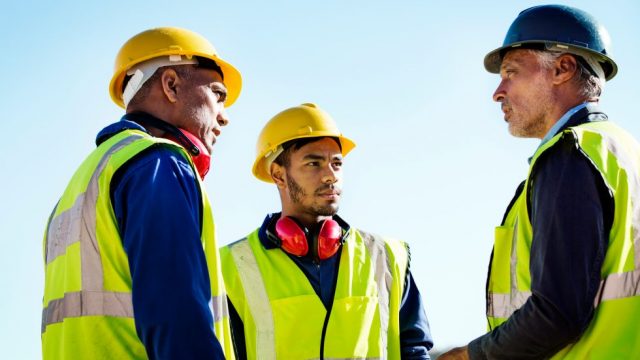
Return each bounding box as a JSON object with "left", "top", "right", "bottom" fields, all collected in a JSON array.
[{"left": 229, "top": 239, "right": 276, "bottom": 359}]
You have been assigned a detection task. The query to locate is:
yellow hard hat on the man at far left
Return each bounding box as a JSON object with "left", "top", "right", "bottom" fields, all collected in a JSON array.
[{"left": 109, "top": 27, "right": 242, "bottom": 108}]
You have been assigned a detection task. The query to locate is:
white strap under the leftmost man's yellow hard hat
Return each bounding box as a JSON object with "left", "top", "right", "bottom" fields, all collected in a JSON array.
[{"left": 122, "top": 55, "right": 198, "bottom": 109}]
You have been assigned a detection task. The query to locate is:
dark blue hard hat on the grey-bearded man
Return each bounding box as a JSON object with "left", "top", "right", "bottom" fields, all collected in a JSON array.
[{"left": 484, "top": 5, "right": 618, "bottom": 80}]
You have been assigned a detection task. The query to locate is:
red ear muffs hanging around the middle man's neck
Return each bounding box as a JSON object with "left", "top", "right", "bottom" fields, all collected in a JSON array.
[{"left": 276, "top": 216, "right": 342, "bottom": 260}]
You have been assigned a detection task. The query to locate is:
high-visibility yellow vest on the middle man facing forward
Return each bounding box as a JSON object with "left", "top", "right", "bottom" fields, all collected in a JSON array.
[{"left": 220, "top": 229, "right": 409, "bottom": 359}]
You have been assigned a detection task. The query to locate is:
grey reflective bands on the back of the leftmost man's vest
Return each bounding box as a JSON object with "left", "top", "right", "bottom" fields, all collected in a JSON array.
[{"left": 42, "top": 135, "right": 142, "bottom": 332}]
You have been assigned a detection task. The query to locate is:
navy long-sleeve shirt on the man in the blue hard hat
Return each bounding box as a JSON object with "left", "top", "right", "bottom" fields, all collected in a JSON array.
[{"left": 468, "top": 106, "right": 614, "bottom": 359}]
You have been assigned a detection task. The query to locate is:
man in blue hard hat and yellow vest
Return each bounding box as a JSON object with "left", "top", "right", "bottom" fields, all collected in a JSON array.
[{"left": 441, "top": 5, "right": 640, "bottom": 359}]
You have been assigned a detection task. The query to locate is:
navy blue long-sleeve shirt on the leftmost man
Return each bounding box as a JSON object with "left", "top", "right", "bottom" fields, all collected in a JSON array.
[{"left": 96, "top": 115, "right": 224, "bottom": 359}]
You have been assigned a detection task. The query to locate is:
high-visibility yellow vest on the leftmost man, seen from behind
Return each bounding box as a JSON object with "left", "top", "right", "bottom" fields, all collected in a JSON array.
[{"left": 42, "top": 130, "right": 233, "bottom": 359}]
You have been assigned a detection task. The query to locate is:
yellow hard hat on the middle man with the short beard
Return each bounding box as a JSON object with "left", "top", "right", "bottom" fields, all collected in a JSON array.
[{"left": 252, "top": 103, "right": 356, "bottom": 183}]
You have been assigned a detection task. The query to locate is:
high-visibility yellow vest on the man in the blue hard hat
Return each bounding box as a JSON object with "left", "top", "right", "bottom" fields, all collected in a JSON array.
[{"left": 487, "top": 121, "right": 640, "bottom": 359}]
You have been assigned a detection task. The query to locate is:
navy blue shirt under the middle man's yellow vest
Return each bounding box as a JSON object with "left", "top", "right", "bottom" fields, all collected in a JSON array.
[{"left": 229, "top": 213, "right": 433, "bottom": 360}]
